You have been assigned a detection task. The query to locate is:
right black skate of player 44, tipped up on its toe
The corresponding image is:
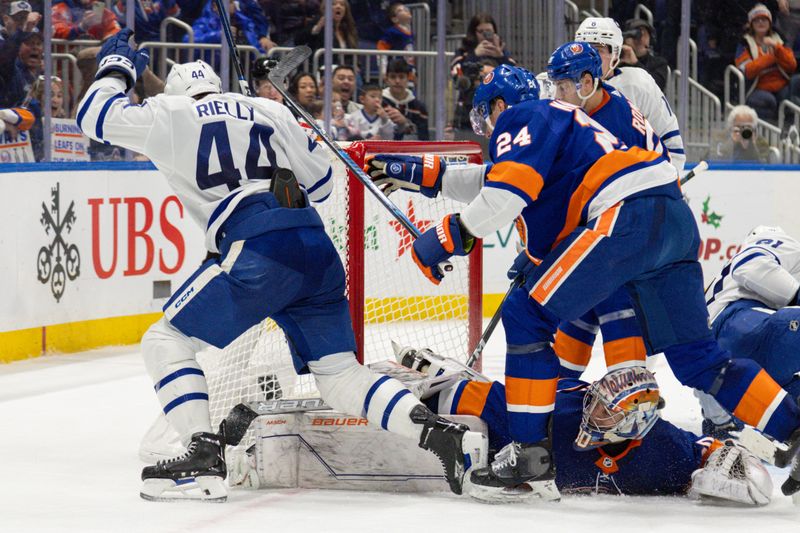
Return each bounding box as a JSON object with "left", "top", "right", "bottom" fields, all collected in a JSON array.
[{"left": 409, "top": 405, "right": 488, "bottom": 494}]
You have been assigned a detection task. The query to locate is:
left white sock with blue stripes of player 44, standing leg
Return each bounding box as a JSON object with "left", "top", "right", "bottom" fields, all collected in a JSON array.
[{"left": 142, "top": 318, "right": 212, "bottom": 445}]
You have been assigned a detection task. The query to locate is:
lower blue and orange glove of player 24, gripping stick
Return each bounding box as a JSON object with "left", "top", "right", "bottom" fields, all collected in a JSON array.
[{"left": 411, "top": 213, "right": 475, "bottom": 285}]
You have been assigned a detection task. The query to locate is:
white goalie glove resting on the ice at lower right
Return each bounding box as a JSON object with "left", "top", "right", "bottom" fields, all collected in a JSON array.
[{"left": 689, "top": 444, "right": 772, "bottom": 505}]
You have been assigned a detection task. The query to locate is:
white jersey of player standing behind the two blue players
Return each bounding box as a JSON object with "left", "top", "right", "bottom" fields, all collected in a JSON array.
[{"left": 606, "top": 67, "right": 686, "bottom": 172}]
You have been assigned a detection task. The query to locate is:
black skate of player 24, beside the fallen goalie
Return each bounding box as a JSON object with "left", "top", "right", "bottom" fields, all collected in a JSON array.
[{"left": 469, "top": 440, "right": 561, "bottom": 503}]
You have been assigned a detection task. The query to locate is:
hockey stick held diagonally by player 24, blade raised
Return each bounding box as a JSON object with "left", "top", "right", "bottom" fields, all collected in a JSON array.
[{"left": 266, "top": 46, "right": 453, "bottom": 273}]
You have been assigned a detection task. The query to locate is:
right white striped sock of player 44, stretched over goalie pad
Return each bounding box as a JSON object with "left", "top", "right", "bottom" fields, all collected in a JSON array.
[{"left": 308, "top": 352, "right": 422, "bottom": 441}]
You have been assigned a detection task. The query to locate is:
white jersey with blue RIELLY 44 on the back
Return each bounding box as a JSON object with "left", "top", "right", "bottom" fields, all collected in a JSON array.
[{"left": 77, "top": 76, "right": 333, "bottom": 252}]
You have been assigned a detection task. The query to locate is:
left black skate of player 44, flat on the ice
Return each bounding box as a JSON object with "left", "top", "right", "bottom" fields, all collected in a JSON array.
[{"left": 139, "top": 428, "right": 228, "bottom": 503}]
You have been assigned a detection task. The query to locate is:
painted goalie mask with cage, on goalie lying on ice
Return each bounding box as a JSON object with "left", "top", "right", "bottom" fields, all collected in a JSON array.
[{"left": 575, "top": 367, "right": 663, "bottom": 450}]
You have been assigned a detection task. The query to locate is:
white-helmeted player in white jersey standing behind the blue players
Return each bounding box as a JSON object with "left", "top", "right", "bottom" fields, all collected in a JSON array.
[{"left": 575, "top": 17, "right": 686, "bottom": 172}]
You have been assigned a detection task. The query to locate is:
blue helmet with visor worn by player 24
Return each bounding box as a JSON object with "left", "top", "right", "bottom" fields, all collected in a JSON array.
[{"left": 470, "top": 65, "right": 539, "bottom": 135}]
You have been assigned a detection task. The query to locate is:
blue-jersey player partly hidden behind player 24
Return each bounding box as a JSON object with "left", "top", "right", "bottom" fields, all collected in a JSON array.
[{"left": 547, "top": 42, "right": 667, "bottom": 378}]
